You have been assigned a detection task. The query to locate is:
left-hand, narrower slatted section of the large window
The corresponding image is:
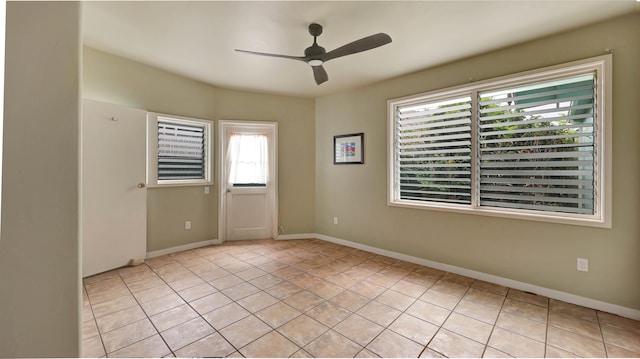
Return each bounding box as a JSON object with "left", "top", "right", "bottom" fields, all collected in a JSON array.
[{"left": 395, "top": 96, "right": 471, "bottom": 204}]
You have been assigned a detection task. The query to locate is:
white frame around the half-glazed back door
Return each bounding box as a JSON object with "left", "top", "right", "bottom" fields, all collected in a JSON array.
[{"left": 217, "top": 120, "right": 279, "bottom": 242}]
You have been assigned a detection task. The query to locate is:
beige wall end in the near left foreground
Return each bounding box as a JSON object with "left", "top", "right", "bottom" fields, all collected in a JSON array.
[{"left": 0, "top": 2, "right": 81, "bottom": 358}]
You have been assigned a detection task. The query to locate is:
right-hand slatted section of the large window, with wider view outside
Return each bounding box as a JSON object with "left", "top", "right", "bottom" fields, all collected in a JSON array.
[{"left": 478, "top": 74, "right": 595, "bottom": 214}]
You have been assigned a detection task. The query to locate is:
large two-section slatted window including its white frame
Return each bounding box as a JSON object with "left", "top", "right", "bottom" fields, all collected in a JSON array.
[{"left": 389, "top": 56, "right": 611, "bottom": 227}]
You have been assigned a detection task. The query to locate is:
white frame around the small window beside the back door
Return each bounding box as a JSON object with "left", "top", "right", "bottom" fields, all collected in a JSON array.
[{"left": 147, "top": 112, "right": 213, "bottom": 188}]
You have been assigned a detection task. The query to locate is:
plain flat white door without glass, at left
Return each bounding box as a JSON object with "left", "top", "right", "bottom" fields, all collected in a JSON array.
[{"left": 82, "top": 100, "right": 147, "bottom": 277}]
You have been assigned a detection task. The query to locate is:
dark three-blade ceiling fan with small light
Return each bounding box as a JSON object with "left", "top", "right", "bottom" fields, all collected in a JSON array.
[{"left": 236, "top": 23, "right": 391, "bottom": 85}]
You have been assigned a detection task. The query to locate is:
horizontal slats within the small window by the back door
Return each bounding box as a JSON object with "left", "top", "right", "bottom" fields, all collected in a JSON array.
[{"left": 158, "top": 119, "right": 206, "bottom": 180}]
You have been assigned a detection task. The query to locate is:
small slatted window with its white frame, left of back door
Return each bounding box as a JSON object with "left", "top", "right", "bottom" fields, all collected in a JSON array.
[{"left": 147, "top": 113, "right": 212, "bottom": 186}]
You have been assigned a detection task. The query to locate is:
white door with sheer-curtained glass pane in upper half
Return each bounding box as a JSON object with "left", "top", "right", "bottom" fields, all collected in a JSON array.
[{"left": 218, "top": 121, "right": 278, "bottom": 241}]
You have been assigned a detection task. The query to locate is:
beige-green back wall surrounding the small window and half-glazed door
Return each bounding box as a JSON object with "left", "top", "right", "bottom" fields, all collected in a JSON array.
[{"left": 83, "top": 48, "right": 315, "bottom": 251}]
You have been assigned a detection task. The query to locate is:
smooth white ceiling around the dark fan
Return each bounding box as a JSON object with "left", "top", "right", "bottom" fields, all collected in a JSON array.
[{"left": 83, "top": 0, "right": 640, "bottom": 97}]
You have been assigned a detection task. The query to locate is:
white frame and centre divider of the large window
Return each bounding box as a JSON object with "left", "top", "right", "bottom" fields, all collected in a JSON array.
[{"left": 387, "top": 54, "right": 612, "bottom": 228}]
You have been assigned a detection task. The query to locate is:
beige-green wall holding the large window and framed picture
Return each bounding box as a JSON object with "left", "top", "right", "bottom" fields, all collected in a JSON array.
[{"left": 316, "top": 13, "right": 640, "bottom": 309}]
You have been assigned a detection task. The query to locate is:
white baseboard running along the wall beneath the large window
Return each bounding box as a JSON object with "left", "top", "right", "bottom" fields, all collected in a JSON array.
[{"left": 312, "top": 234, "right": 640, "bottom": 320}]
